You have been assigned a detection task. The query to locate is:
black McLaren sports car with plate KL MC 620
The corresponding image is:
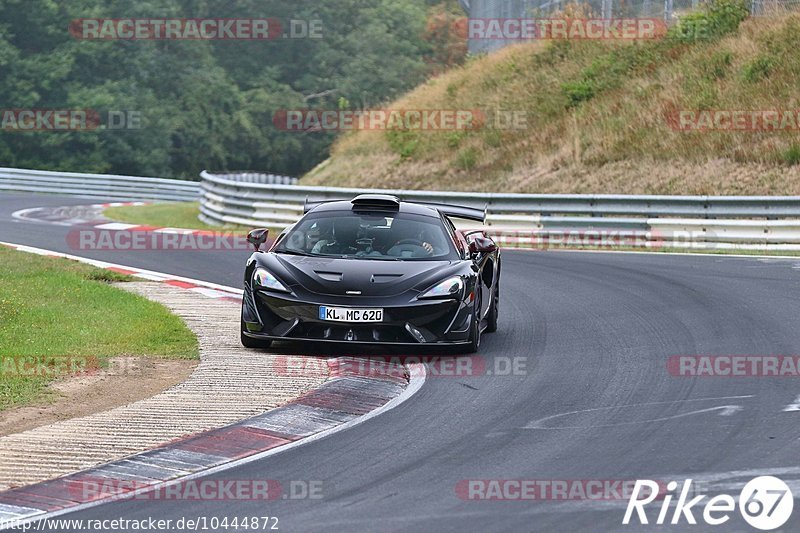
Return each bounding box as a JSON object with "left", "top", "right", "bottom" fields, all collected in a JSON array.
[{"left": 242, "top": 194, "right": 500, "bottom": 352}]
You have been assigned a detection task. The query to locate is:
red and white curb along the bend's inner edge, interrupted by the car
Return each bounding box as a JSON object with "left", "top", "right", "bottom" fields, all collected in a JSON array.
[{"left": 0, "top": 242, "right": 426, "bottom": 530}]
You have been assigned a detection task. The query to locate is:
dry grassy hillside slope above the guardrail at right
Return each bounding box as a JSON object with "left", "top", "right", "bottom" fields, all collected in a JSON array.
[{"left": 302, "top": 8, "right": 800, "bottom": 194}]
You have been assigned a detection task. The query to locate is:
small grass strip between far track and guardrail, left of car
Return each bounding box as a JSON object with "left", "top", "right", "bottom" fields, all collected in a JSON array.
[{"left": 104, "top": 202, "right": 241, "bottom": 230}]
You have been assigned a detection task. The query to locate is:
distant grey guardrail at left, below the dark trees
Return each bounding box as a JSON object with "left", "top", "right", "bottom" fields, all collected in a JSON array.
[{"left": 0, "top": 168, "right": 200, "bottom": 202}]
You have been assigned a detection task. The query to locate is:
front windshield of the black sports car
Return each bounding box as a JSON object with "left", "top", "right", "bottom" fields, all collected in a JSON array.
[{"left": 275, "top": 211, "right": 456, "bottom": 261}]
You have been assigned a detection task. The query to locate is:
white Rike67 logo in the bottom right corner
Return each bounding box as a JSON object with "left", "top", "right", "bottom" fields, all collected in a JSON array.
[{"left": 622, "top": 476, "right": 794, "bottom": 531}]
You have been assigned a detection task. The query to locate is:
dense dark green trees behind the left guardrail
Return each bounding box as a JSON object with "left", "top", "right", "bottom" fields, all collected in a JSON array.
[{"left": 0, "top": 0, "right": 456, "bottom": 179}]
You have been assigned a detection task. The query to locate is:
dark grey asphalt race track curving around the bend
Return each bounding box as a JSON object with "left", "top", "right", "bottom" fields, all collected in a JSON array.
[{"left": 0, "top": 194, "right": 800, "bottom": 531}]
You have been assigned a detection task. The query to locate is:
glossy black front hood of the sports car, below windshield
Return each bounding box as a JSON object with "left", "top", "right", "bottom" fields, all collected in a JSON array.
[{"left": 270, "top": 254, "right": 457, "bottom": 296}]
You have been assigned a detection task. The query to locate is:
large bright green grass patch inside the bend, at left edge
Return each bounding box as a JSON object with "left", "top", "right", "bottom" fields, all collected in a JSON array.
[{"left": 0, "top": 247, "right": 199, "bottom": 411}]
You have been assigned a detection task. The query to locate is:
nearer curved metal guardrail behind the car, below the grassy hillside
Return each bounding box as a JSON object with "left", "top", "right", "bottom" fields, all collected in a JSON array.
[{"left": 200, "top": 171, "right": 800, "bottom": 250}]
